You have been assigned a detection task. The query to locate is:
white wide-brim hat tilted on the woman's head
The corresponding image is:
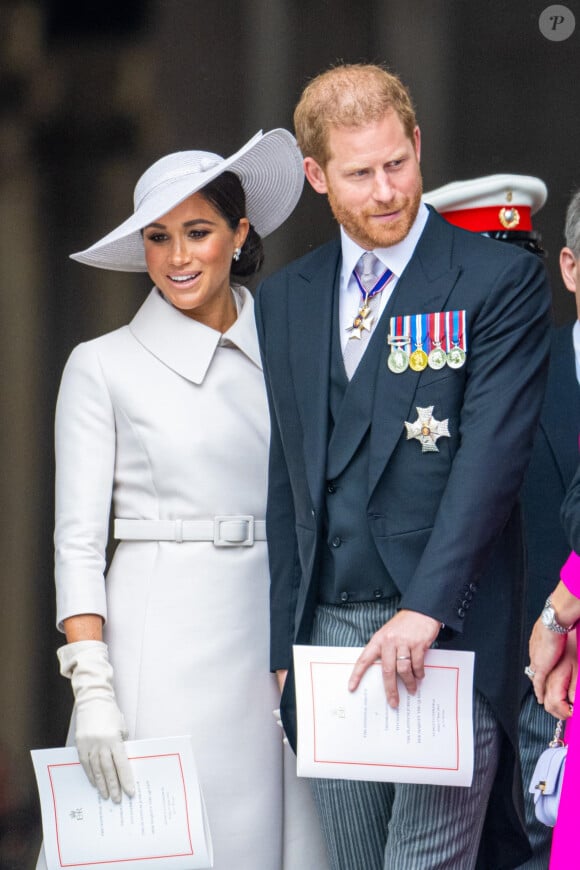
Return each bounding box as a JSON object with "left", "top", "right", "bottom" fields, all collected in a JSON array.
[{"left": 71, "top": 129, "right": 304, "bottom": 272}]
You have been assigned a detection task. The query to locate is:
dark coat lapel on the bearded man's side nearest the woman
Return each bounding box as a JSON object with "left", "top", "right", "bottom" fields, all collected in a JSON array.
[{"left": 288, "top": 241, "right": 340, "bottom": 508}]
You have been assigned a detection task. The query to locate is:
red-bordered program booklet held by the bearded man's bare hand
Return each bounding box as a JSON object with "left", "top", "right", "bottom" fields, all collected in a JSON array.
[{"left": 294, "top": 646, "right": 474, "bottom": 786}]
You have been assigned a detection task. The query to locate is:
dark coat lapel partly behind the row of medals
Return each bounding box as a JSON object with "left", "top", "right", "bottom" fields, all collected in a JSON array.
[{"left": 369, "top": 212, "right": 461, "bottom": 496}]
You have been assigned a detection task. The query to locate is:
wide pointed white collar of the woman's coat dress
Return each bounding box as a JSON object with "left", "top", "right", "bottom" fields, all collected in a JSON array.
[{"left": 129, "top": 286, "right": 262, "bottom": 384}]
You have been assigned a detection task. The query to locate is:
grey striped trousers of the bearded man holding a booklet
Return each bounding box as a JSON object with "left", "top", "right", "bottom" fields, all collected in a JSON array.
[{"left": 310, "top": 598, "right": 500, "bottom": 870}]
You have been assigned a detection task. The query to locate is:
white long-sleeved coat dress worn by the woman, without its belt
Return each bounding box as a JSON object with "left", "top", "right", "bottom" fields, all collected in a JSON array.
[{"left": 55, "top": 288, "right": 327, "bottom": 870}]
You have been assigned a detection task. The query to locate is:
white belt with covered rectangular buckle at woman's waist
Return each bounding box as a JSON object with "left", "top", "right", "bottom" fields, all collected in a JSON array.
[{"left": 115, "top": 515, "right": 266, "bottom": 547}]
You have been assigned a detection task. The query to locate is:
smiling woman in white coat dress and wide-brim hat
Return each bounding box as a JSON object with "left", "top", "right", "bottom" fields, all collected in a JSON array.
[{"left": 46, "top": 130, "right": 326, "bottom": 870}]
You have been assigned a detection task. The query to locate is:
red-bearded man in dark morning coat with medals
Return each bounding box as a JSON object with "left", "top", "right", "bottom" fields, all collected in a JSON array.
[{"left": 256, "top": 65, "right": 550, "bottom": 870}]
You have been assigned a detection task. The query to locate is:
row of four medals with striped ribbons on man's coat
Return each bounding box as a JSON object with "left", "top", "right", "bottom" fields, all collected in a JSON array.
[{"left": 387, "top": 310, "right": 467, "bottom": 374}]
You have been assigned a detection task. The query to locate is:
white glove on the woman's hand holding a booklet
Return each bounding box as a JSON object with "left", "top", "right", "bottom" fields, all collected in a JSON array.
[{"left": 57, "top": 640, "right": 135, "bottom": 803}]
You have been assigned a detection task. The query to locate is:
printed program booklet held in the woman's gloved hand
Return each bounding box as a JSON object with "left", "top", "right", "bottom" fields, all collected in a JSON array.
[{"left": 31, "top": 737, "right": 213, "bottom": 870}]
